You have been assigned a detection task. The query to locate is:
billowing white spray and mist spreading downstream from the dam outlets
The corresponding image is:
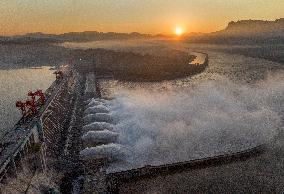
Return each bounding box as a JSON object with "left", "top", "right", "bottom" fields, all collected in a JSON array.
[{"left": 107, "top": 75, "right": 284, "bottom": 170}]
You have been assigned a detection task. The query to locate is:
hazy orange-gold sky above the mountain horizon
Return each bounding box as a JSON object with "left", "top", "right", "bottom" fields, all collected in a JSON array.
[{"left": 0, "top": 0, "right": 284, "bottom": 35}]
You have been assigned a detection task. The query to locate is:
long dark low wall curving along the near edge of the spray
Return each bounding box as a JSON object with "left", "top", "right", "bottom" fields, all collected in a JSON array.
[{"left": 106, "top": 145, "right": 265, "bottom": 193}]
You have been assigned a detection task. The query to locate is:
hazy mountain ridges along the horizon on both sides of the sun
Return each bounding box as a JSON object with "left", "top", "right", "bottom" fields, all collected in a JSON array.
[{"left": 0, "top": 18, "right": 284, "bottom": 44}]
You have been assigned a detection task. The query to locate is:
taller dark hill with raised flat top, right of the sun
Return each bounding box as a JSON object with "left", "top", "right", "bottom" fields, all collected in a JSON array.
[{"left": 185, "top": 18, "right": 284, "bottom": 44}]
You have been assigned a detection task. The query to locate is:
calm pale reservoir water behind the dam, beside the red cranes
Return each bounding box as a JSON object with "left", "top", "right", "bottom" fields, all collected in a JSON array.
[{"left": 0, "top": 66, "right": 55, "bottom": 137}]
